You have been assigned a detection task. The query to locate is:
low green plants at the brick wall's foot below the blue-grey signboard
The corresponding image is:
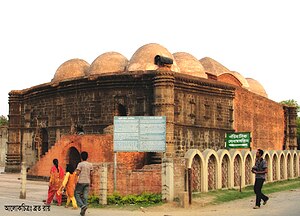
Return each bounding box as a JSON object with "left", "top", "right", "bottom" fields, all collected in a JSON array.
[{"left": 107, "top": 193, "right": 162, "bottom": 205}]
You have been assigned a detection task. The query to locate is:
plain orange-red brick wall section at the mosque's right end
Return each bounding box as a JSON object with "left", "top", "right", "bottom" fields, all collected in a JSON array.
[{"left": 234, "top": 88, "right": 285, "bottom": 150}]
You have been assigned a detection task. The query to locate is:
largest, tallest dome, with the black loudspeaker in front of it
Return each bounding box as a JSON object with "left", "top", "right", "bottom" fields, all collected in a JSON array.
[{"left": 127, "top": 43, "right": 179, "bottom": 72}]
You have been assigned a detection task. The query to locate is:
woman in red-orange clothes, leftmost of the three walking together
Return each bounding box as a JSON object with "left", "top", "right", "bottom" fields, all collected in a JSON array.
[{"left": 46, "top": 159, "right": 65, "bottom": 206}]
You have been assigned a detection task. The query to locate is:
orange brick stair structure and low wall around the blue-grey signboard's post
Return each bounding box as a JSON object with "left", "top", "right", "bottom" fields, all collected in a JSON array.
[{"left": 28, "top": 134, "right": 161, "bottom": 195}]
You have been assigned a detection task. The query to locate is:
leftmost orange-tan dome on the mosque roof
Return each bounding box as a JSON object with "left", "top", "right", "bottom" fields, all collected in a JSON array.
[{"left": 52, "top": 59, "right": 90, "bottom": 82}]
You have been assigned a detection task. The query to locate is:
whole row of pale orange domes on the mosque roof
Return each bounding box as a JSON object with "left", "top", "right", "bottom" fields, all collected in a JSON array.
[{"left": 51, "top": 43, "right": 267, "bottom": 97}]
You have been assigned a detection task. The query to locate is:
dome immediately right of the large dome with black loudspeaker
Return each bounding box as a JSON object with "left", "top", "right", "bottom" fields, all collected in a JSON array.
[{"left": 173, "top": 52, "right": 207, "bottom": 78}]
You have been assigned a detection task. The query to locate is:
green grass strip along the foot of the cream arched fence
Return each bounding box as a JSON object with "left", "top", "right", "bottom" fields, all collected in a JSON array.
[{"left": 193, "top": 178, "right": 300, "bottom": 204}]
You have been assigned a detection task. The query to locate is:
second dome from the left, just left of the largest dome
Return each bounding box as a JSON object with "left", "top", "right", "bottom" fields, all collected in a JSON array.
[{"left": 88, "top": 52, "right": 128, "bottom": 75}]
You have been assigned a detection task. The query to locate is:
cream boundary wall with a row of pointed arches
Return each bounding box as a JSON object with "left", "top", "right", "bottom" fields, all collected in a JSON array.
[{"left": 185, "top": 149, "right": 300, "bottom": 192}]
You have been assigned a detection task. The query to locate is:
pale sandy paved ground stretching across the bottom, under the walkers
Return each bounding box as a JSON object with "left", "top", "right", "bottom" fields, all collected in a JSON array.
[{"left": 0, "top": 168, "right": 300, "bottom": 216}]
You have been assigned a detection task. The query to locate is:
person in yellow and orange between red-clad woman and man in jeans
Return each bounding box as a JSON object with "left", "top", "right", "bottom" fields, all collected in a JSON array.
[{"left": 59, "top": 164, "right": 78, "bottom": 209}]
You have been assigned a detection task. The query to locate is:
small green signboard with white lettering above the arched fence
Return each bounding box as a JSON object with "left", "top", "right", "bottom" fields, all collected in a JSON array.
[{"left": 225, "top": 132, "right": 251, "bottom": 148}]
